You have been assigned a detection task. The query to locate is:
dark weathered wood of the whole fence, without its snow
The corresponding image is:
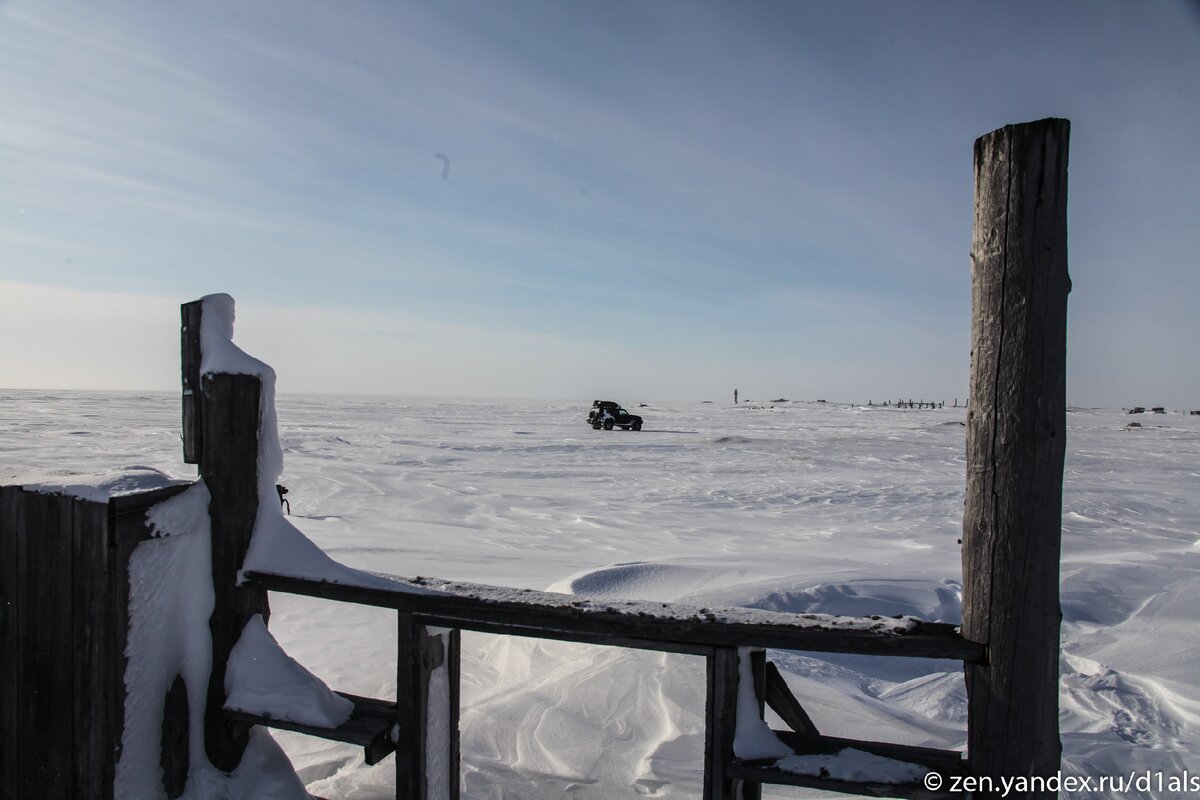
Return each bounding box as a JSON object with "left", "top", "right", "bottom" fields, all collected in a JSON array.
[{"left": 0, "top": 120, "right": 1069, "bottom": 800}]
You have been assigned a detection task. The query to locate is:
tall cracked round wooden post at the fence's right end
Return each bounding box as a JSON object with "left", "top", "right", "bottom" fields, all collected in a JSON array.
[{"left": 962, "top": 119, "right": 1070, "bottom": 796}]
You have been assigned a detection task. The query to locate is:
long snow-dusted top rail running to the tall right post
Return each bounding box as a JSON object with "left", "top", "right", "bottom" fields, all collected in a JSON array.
[{"left": 246, "top": 572, "right": 983, "bottom": 661}]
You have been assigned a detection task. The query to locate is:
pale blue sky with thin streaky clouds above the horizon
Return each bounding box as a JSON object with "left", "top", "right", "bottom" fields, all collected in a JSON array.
[{"left": 0, "top": 0, "right": 1200, "bottom": 409}]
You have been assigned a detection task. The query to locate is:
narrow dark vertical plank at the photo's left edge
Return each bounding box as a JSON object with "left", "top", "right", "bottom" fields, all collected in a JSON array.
[{"left": 0, "top": 486, "right": 23, "bottom": 799}]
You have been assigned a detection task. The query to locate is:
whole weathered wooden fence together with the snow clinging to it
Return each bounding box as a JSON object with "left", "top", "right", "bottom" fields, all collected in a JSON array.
[{"left": 0, "top": 120, "right": 1069, "bottom": 800}]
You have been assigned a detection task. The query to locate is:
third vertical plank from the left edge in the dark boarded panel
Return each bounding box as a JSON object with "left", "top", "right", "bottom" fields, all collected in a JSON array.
[{"left": 72, "top": 500, "right": 120, "bottom": 800}]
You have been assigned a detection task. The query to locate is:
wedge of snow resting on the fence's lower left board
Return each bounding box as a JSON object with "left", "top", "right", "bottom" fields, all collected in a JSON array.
[{"left": 226, "top": 614, "right": 354, "bottom": 728}]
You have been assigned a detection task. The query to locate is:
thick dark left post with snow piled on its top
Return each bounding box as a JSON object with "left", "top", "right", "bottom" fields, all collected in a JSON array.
[{"left": 200, "top": 374, "right": 269, "bottom": 772}]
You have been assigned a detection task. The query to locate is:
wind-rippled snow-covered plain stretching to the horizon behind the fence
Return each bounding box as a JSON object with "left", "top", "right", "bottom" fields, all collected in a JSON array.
[{"left": 0, "top": 391, "right": 1200, "bottom": 800}]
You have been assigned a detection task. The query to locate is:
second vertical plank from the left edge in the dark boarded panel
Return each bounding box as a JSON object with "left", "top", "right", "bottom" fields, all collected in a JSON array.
[{"left": 17, "top": 492, "right": 74, "bottom": 798}]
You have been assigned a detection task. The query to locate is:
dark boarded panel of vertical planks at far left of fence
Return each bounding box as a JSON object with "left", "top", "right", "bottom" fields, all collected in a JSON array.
[{"left": 0, "top": 486, "right": 186, "bottom": 800}]
